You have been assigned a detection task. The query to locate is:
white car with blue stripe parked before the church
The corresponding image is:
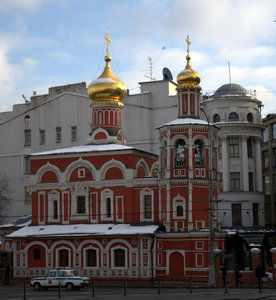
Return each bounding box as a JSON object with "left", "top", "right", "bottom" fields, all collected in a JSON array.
[{"left": 30, "top": 269, "right": 90, "bottom": 291}]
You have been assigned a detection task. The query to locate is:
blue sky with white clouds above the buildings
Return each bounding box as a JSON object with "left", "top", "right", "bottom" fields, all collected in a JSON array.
[{"left": 0, "top": 0, "right": 276, "bottom": 113}]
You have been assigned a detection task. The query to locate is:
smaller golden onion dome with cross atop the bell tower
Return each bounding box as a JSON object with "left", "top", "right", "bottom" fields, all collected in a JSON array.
[{"left": 177, "top": 36, "right": 200, "bottom": 88}]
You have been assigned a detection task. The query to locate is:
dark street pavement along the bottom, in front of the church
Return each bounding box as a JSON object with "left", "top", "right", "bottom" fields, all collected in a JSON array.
[{"left": 0, "top": 285, "right": 276, "bottom": 300}]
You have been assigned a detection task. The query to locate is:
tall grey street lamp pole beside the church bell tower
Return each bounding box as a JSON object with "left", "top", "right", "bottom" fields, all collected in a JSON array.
[{"left": 200, "top": 107, "right": 216, "bottom": 286}]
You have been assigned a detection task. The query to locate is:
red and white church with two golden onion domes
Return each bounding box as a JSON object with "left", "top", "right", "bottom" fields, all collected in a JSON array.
[{"left": 5, "top": 37, "right": 224, "bottom": 282}]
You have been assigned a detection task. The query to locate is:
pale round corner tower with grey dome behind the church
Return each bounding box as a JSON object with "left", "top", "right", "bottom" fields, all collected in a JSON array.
[{"left": 202, "top": 83, "right": 265, "bottom": 228}]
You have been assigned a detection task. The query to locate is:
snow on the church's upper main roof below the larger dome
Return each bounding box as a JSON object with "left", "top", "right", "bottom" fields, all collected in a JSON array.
[{"left": 31, "top": 144, "right": 135, "bottom": 156}]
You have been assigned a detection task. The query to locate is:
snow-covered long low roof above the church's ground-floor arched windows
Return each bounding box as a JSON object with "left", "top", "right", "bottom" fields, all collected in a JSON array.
[{"left": 7, "top": 224, "right": 158, "bottom": 238}]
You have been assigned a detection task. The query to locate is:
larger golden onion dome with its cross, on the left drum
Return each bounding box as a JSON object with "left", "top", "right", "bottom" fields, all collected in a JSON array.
[{"left": 88, "top": 31, "right": 127, "bottom": 106}]
